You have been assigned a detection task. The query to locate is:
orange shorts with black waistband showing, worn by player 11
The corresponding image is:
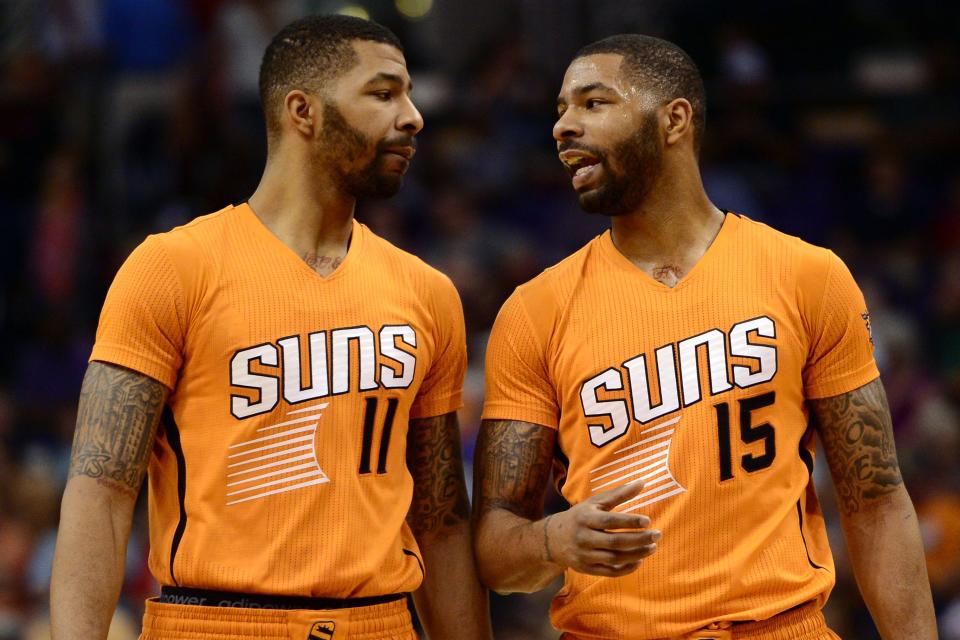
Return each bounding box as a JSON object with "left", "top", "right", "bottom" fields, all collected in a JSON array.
[{"left": 140, "top": 598, "right": 418, "bottom": 640}]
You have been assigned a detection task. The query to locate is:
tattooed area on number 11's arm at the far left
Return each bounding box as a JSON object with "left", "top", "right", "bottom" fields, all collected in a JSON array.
[{"left": 70, "top": 362, "right": 167, "bottom": 495}]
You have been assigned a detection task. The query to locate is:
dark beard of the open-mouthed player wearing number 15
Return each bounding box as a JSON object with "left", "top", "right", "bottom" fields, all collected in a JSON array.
[{"left": 561, "top": 113, "right": 663, "bottom": 216}]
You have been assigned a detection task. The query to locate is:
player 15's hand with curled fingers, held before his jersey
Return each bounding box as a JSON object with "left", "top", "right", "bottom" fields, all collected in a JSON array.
[{"left": 544, "top": 481, "right": 661, "bottom": 577}]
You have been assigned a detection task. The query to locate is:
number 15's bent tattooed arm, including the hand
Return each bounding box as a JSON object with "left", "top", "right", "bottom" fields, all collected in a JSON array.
[{"left": 473, "top": 420, "right": 660, "bottom": 592}]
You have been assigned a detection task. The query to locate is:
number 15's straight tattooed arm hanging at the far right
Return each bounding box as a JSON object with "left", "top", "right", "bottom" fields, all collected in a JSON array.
[{"left": 810, "top": 379, "right": 937, "bottom": 640}]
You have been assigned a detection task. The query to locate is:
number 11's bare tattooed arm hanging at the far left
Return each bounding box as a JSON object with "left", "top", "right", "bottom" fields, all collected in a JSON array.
[{"left": 50, "top": 362, "right": 168, "bottom": 639}]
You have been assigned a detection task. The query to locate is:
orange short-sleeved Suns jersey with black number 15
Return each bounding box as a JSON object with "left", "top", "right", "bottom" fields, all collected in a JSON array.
[{"left": 483, "top": 214, "right": 878, "bottom": 639}]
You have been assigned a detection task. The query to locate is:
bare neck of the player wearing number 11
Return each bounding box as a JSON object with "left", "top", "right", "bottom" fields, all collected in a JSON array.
[{"left": 249, "top": 150, "right": 356, "bottom": 264}]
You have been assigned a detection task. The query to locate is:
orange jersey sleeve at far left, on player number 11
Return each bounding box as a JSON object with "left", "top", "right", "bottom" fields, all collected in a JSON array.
[{"left": 90, "top": 236, "right": 185, "bottom": 389}]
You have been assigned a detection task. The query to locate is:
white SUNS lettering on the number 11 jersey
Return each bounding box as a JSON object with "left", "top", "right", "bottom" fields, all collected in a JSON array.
[{"left": 230, "top": 324, "right": 417, "bottom": 420}]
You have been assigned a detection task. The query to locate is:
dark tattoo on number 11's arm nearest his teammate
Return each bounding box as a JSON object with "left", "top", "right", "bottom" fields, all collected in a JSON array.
[{"left": 407, "top": 413, "right": 470, "bottom": 540}]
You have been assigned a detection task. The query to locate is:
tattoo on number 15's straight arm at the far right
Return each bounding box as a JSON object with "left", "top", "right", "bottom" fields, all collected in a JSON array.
[{"left": 810, "top": 379, "right": 903, "bottom": 515}]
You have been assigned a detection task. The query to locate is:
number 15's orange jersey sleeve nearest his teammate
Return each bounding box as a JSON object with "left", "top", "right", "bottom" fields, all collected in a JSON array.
[{"left": 483, "top": 291, "right": 560, "bottom": 429}]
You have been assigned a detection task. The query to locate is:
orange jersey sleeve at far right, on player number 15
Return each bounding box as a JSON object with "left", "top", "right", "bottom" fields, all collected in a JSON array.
[{"left": 803, "top": 252, "right": 880, "bottom": 399}]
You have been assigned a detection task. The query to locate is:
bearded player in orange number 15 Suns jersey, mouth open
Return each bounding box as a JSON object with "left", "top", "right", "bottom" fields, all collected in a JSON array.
[{"left": 475, "top": 35, "right": 936, "bottom": 640}]
